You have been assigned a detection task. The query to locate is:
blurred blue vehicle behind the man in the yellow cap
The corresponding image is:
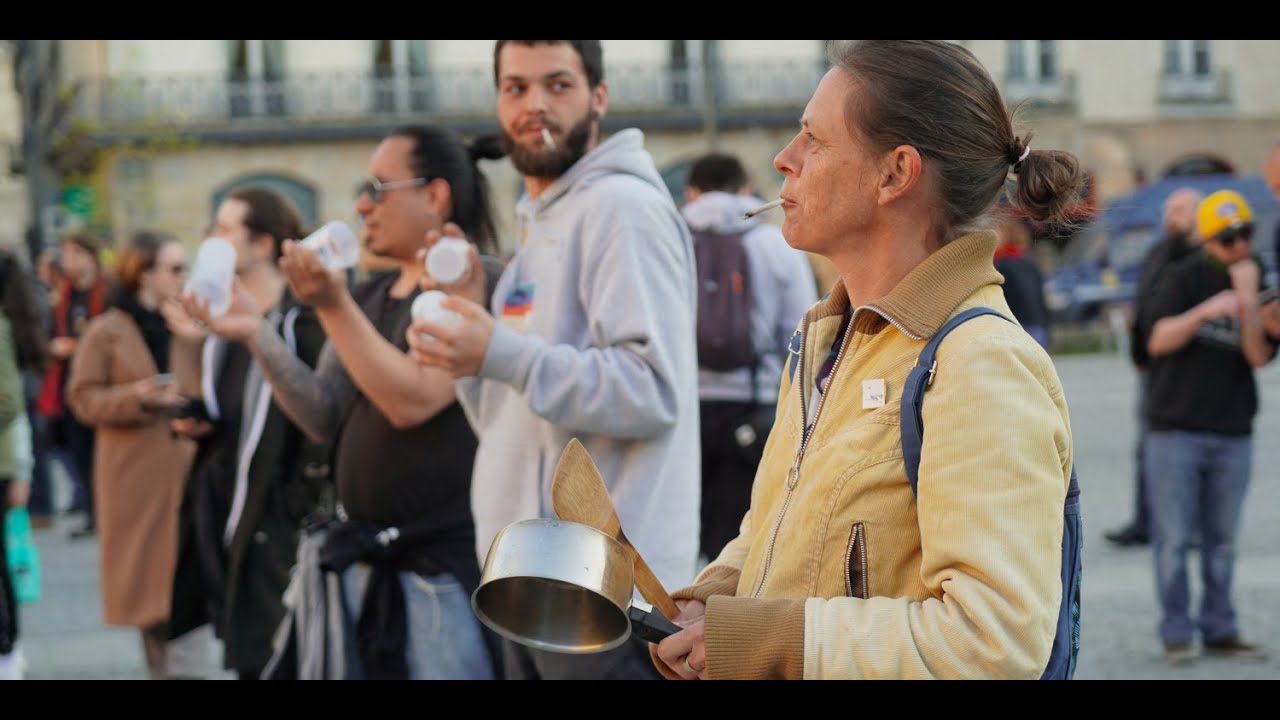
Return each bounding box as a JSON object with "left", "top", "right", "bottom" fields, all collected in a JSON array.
[{"left": 1044, "top": 176, "right": 1280, "bottom": 323}]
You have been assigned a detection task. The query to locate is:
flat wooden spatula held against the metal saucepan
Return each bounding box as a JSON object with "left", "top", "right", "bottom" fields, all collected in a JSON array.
[{"left": 552, "top": 438, "right": 680, "bottom": 620}]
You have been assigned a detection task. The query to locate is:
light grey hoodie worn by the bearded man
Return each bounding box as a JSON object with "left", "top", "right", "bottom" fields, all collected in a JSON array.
[{"left": 458, "top": 129, "right": 701, "bottom": 591}]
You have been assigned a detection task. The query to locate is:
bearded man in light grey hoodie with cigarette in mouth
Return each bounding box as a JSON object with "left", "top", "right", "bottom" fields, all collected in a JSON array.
[{"left": 407, "top": 40, "right": 700, "bottom": 679}]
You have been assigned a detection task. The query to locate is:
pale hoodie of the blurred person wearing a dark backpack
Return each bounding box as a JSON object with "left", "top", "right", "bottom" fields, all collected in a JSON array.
[{"left": 681, "top": 192, "right": 818, "bottom": 405}]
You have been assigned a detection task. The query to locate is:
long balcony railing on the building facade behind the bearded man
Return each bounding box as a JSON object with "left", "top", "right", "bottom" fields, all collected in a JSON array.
[{"left": 77, "top": 60, "right": 826, "bottom": 129}]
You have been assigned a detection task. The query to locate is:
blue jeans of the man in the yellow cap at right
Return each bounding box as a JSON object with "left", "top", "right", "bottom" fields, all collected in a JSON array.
[{"left": 1143, "top": 432, "right": 1253, "bottom": 643}]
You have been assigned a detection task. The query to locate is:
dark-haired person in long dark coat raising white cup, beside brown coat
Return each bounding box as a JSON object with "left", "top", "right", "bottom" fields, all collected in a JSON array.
[{"left": 172, "top": 187, "right": 329, "bottom": 678}]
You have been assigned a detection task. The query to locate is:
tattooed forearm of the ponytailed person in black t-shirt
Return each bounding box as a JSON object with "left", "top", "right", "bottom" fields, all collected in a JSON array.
[{"left": 248, "top": 323, "right": 356, "bottom": 443}]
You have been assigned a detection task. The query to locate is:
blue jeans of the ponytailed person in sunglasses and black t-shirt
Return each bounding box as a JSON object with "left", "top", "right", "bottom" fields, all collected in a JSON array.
[{"left": 342, "top": 562, "right": 493, "bottom": 680}]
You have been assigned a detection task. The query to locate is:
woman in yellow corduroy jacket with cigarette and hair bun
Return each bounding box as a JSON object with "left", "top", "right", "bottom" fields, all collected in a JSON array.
[{"left": 654, "top": 40, "right": 1084, "bottom": 679}]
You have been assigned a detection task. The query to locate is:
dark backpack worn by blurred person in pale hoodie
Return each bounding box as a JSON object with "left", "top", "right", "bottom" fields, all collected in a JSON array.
[{"left": 692, "top": 231, "right": 756, "bottom": 372}]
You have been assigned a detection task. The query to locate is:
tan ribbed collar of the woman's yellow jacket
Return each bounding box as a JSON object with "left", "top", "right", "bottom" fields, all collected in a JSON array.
[{"left": 809, "top": 231, "right": 1004, "bottom": 338}]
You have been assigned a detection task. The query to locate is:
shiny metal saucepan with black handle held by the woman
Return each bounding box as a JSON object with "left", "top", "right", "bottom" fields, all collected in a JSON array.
[{"left": 471, "top": 519, "right": 681, "bottom": 655}]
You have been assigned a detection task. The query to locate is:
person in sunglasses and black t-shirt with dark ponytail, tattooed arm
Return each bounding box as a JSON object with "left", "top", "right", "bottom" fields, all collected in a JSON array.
[{"left": 204, "top": 126, "right": 499, "bottom": 679}]
